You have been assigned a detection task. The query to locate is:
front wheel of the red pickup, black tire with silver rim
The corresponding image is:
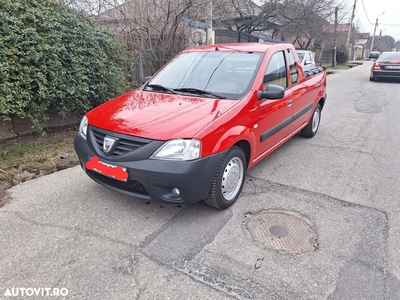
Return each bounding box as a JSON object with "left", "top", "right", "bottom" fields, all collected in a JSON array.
[{"left": 204, "top": 146, "right": 247, "bottom": 209}]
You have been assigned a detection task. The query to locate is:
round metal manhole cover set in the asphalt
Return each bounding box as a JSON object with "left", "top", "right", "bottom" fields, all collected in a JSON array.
[{"left": 243, "top": 211, "right": 318, "bottom": 253}]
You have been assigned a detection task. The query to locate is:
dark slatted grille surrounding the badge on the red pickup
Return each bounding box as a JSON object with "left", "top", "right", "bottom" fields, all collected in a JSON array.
[{"left": 90, "top": 127, "right": 151, "bottom": 156}]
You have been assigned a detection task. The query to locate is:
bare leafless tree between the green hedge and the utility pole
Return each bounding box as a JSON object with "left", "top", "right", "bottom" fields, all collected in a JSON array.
[{"left": 64, "top": 0, "right": 212, "bottom": 81}]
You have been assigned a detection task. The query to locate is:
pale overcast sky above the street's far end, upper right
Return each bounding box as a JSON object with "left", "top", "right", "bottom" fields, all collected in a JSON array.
[{"left": 354, "top": 0, "right": 400, "bottom": 41}]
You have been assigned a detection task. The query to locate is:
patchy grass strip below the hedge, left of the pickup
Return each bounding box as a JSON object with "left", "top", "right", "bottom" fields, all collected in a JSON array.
[{"left": 0, "top": 126, "right": 78, "bottom": 172}]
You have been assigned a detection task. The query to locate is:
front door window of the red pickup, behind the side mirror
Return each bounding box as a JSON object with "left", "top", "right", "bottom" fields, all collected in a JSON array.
[{"left": 263, "top": 51, "right": 288, "bottom": 90}]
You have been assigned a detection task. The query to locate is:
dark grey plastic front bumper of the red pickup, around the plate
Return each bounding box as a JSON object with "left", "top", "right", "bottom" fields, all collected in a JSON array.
[{"left": 74, "top": 133, "right": 225, "bottom": 204}]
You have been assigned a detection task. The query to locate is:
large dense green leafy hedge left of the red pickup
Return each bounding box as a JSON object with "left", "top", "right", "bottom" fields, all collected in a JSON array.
[{"left": 0, "top": 0, "right": 128, "bottom": 130}]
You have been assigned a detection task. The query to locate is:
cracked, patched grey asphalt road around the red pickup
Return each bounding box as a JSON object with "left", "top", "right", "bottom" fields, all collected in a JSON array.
[{"left": 0, "top": 62, "right": 400, "bottom": 300}]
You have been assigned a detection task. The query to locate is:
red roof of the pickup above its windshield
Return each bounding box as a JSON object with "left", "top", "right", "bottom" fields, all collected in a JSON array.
[{"left": 183, "top": 42, "right": 285, "bottom": 52}]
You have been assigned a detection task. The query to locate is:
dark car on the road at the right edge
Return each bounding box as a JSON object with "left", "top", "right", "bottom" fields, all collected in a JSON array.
[{"left": 369, "top": 52, "right": 400, "bottom": 81}]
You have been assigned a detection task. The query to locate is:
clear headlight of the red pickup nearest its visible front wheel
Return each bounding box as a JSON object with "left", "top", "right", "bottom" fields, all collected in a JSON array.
[{"left": 150, "top": 139, "right": 201, "bottom": 160}]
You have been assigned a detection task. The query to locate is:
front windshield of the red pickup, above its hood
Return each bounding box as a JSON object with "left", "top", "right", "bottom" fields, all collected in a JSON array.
[{"left": 145, "top": 51, "right": 263, "bottom": 100}]
